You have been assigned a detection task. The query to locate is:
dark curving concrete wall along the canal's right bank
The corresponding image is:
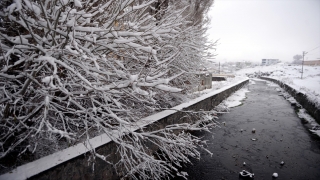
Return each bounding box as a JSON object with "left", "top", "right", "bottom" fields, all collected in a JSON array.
[{"left": 260, "top": 77, "right": 320, "bottom": 124}]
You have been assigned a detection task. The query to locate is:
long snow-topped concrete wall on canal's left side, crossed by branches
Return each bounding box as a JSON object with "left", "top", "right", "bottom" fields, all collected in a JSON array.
[{"left": 0, "top": 79, "right": 249, "bottom": 180}]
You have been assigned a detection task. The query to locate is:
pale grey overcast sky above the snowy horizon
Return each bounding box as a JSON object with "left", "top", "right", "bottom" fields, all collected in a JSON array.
[{"left": 208, "top": 0, "right": 320, "bottom": 62}]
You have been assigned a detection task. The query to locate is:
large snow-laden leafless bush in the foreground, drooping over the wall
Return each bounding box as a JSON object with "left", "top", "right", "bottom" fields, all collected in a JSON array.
[{"left": 0, "top": 0, "right": 214, "bottom": 179}]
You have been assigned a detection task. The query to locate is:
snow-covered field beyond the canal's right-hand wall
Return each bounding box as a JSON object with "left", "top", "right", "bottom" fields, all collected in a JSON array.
[{"left": 236, "top": 64, "right": 320, "bottom": 107}]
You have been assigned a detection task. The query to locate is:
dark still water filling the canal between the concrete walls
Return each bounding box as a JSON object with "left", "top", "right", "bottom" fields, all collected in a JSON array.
[{"left": 175, "top": 81, "right": 320, "bottom": 180}]
